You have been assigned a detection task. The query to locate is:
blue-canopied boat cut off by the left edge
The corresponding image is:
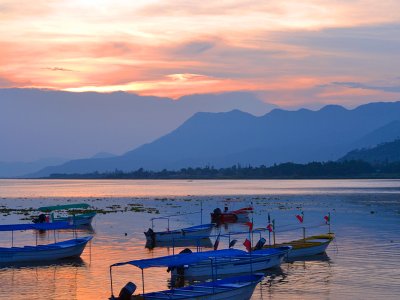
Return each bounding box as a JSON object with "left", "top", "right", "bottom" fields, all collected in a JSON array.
[{"left": 0, "top": 222, "right": 92, "bottom": 264}]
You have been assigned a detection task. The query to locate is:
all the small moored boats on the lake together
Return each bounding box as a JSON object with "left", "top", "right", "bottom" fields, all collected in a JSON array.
[{"left": 0, "top": 204, "right": 335, "bottom": 300}]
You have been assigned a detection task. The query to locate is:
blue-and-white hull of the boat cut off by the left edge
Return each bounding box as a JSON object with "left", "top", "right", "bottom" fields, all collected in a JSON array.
[{"left": 0, "top": 237, "right": 92, "bottom": 264}]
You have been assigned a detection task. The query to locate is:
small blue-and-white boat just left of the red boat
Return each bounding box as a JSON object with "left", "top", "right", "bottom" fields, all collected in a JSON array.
[{"left": 144, "top": 223, "right": 214, "bottom": 243}]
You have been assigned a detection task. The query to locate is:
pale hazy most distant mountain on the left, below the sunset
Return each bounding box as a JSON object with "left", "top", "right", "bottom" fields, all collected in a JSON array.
[{"left": 0, "top": 89, "right": 276, "bottom": 162}]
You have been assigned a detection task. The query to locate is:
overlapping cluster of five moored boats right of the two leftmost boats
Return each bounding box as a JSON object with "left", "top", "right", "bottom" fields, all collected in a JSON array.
[{"left": 110, "top": 208, "right": 334, "bottom": 300}]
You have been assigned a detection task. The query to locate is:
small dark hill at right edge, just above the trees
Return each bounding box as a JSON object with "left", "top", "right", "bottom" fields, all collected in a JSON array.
[{"left": 340, "top": 139, "right": 400, "bottom": 164}]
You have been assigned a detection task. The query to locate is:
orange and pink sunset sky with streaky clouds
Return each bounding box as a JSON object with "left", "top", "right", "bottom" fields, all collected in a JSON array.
[{"left": 0, "top": 0, "right": 400, "bottom": 107}]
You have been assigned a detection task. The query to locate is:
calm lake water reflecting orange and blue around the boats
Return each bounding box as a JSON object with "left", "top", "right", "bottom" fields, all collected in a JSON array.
[{"left": 0, "top": 180, "right": 400, "bottom": 300}]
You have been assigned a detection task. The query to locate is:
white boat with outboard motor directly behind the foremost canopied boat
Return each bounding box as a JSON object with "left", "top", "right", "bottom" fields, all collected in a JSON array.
[{"left": 171, "top": 246, "right": 292, "bottom": 280}]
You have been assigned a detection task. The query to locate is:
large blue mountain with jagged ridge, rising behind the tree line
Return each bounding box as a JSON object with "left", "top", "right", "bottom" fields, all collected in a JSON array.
[{"left": 29, "top": 102, "right": 400, "bottom": 176}]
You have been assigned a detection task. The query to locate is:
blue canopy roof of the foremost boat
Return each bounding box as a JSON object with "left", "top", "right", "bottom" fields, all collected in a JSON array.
[{"left": 111, "top": 249, "right": 247, "bottom": 269}]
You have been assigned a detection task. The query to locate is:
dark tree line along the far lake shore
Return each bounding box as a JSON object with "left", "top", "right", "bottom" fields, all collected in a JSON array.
[{"left": 49, "top": 160, "right": 400, "bottom": 179}]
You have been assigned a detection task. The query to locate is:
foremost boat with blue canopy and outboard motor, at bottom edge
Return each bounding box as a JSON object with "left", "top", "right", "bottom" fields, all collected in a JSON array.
[{"left": 110, "top": 252, "right": 264, "bottom": 300}]
